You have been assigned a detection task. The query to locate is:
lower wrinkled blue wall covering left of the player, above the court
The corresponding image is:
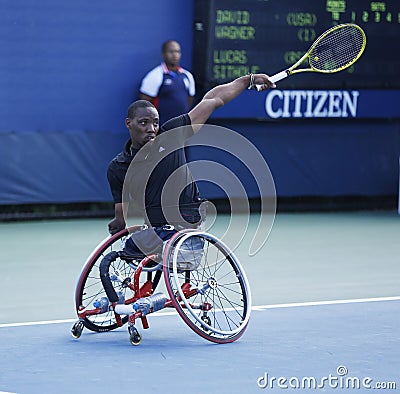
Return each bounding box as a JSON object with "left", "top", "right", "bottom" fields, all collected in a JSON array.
[{"left": 0, "top": 131, "right": 126, "bottom": 204}]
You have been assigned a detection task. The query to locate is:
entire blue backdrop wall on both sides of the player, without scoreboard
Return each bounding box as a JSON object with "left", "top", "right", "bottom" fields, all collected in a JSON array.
[{"left": 0, "top": 0, "right": 400, "bottom": 204}]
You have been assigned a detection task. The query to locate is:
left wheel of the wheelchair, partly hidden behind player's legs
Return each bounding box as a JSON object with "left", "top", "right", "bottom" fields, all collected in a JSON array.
[{"left": 75, "top": 227, "right": 141, "bottom": 332}]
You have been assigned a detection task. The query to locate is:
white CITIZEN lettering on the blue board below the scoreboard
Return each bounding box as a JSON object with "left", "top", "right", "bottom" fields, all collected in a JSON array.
[{"left": 265, "top": 90, "right": 359, "bottom": 118}]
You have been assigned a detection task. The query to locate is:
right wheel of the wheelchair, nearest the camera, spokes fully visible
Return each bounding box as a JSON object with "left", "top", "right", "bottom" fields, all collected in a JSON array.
[{"left": 163, "top": 231, "right": 251, "bottom": 343}]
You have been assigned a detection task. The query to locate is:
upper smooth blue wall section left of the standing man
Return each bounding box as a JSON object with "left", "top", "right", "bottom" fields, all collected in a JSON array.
[{"left": 0, "top": 0, "right": 193, "bottom": 132}]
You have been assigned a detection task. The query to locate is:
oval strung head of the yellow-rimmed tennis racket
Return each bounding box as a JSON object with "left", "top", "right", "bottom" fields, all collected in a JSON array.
[{"left": 309, "top": 26, "right": 365, "bottom": 72}]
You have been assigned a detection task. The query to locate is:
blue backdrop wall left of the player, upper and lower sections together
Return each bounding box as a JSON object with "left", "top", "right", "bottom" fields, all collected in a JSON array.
[{"left": 0, "top": 0, "right": 193, "bottom": 204}]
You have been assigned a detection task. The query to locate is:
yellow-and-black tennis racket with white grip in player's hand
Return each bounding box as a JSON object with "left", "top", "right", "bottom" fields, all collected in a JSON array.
[{"left": 260, "top": 23, "right": 367, "bottom": 83}]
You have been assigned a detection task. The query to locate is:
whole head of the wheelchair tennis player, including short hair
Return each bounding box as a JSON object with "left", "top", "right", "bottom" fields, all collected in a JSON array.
[{"left": 125, "top": 100, "right": 159, "bottom": 149}]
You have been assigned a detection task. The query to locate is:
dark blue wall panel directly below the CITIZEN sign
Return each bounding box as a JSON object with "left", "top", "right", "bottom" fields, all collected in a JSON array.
[{"left": 209, "top": 119, "right": 400, "bottom": 197}]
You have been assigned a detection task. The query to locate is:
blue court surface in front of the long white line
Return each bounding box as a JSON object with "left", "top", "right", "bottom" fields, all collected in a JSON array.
[{"left": 0, "top": 300, "right": 400, "bottom": 393}]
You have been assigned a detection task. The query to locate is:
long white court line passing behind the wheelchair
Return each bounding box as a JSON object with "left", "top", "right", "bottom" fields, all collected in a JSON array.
[{"left": 0, "top": 296, "right": 400, "bottom": 330}]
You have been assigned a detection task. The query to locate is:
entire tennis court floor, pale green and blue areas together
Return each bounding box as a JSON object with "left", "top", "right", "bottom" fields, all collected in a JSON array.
[{"left": 0, "top": 214, "right": 400, "bottom": 394}]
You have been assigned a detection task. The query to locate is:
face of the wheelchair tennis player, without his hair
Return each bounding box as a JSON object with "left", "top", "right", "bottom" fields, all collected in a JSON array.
[{"left": 125, "top": 107, "right": 159, "bottom": 149}]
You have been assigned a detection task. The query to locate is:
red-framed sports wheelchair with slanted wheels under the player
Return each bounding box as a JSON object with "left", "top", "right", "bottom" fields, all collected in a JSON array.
[{"left": 71, "top": 226, "right": 251, "bottom": 345}]
